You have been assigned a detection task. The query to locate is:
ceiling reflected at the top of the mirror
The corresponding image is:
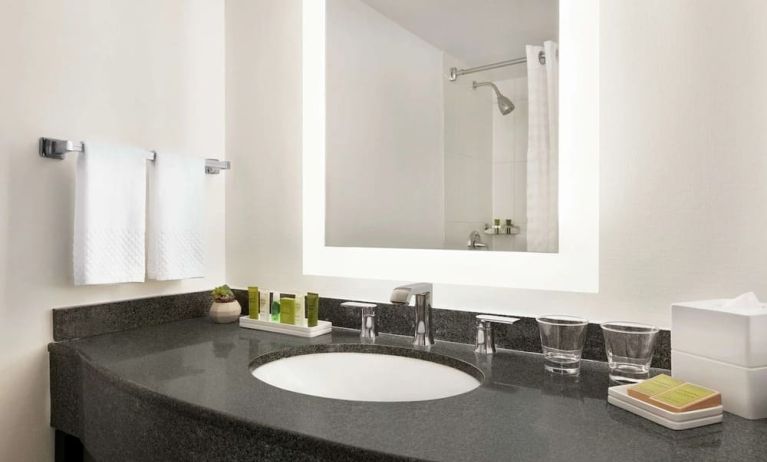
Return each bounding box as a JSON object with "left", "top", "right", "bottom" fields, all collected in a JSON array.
[{"left": 362, "top": 0, "right": 559, "bottom": 67}]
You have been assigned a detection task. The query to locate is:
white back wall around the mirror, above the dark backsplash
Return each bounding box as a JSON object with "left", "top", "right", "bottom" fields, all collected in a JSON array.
[{"left": 227, "top": 0, "right": 767, "bottom": 327}]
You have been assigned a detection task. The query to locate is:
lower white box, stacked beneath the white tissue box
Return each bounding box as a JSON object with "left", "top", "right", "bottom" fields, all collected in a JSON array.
[{"left": 671, "top": 350, "right": 767, "bottom": 420}]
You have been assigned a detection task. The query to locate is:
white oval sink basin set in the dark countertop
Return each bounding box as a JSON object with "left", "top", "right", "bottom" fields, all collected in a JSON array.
[{"left": 252, "top": 352, "right": 480, "bottom": 402}]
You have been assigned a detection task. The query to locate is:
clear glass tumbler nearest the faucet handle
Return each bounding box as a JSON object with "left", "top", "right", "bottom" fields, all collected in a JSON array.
[{"left": 535, "top": 315, "right": 589, "bottom": 375}]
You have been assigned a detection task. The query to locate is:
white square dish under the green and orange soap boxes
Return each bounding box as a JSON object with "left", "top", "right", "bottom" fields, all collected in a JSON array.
[{"left": 607, "top": 384, "right": 722, "bottom": 430}]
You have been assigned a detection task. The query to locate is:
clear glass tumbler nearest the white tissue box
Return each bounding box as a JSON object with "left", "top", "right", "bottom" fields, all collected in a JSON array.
[{"left": 602, "top": 322, "right": 658, "bottom": 382}]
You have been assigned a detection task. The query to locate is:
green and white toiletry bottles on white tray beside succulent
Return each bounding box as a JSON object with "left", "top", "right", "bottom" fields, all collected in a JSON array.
[{"left": 240, "top": 287, "right": 333, "bottom": 337}]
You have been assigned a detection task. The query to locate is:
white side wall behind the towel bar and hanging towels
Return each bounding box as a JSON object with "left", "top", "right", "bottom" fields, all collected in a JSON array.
[{"left": 0, "top": 0, "right": 226, "bottom": 461}]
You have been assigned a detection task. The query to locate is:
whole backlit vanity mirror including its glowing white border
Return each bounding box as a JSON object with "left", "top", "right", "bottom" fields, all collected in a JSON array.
[{"left": 302, "top": 0, "right": 599, "bottom": 292}]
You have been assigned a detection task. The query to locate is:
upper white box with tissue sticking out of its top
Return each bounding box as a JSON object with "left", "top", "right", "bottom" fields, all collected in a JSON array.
[{"left": 671, "top": 299, "right": 767, "bottom": 367}]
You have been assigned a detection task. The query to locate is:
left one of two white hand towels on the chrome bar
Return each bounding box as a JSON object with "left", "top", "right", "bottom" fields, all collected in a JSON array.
[{"left": 73, "top": 142, "right": 147, "bottom": 285}]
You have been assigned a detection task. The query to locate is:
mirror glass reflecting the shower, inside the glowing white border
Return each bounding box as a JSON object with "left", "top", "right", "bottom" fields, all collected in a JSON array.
[{"left": 324, "top": 0, "right": 559, "bottom": 253}]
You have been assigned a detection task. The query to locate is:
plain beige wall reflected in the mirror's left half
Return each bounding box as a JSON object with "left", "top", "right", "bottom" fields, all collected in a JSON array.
[{"left": 326, "top": 0, "right": 444, "bottom": 248}]
